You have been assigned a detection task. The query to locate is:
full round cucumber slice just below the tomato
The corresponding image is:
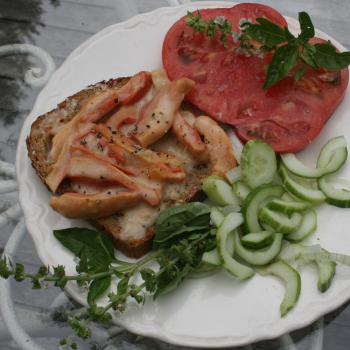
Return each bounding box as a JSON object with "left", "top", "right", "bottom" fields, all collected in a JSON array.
[{"left": 241, "top": 140, "right": 277, "bottom": 188}]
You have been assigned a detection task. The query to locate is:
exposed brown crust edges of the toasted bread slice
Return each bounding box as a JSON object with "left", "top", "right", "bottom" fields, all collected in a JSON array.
[{"left": 26, "top": 77, "right": 210, "bottom": 259}]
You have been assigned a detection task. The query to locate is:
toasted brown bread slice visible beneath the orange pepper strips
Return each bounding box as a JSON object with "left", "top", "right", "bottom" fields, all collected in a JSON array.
[{"left": 27, "top": 78, "right": 210, "bottom": 258}]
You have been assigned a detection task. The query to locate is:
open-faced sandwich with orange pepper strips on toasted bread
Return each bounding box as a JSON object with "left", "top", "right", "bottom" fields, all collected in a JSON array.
[{"left": 27, "top": 69, "right": 236, "bottom": 258}]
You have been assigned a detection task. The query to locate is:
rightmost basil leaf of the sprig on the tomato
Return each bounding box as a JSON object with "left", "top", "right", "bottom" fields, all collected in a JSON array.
[{"left": 314, "top": 41, "right": 350, "bottom": 70}]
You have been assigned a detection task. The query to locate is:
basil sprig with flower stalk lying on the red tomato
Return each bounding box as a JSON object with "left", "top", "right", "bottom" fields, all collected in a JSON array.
[{"left": 185, "top": 10, "right": 350, "bottom": 89}]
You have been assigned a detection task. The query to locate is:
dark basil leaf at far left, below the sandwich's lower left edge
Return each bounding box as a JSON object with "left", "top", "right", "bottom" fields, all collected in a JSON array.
[{"left": 53, "top": 227, "right": 115, "bottom": 265}]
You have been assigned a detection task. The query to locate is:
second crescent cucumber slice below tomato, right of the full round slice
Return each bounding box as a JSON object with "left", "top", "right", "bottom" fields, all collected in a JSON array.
[{"left": 278, "top": 162, "right": 326, "bottom": 203}]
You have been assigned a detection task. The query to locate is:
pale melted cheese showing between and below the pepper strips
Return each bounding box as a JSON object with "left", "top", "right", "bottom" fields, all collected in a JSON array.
[{"left": 52, "top": 70, "right": 208, "bottom": 241}]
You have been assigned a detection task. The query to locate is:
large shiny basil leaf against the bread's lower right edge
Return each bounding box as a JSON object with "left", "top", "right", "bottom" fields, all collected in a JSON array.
[{"left": 154, "top": 202, "right": 210, "bottom": 242}]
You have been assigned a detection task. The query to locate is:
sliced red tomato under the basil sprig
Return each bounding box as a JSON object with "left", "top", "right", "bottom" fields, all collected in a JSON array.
[{"left": 163, "top": 4, "right": 346, "bottom": 153}]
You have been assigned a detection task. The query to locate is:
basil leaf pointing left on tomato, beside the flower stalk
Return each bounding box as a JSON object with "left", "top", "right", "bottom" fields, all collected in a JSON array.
[{"left": 245, "top": 17, "right": 286, "bottom": 46}]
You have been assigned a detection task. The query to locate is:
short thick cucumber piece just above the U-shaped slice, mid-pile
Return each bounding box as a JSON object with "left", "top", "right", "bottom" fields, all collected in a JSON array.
[{"left": 258, "top": 207, "right": 303, "bottom": 234}]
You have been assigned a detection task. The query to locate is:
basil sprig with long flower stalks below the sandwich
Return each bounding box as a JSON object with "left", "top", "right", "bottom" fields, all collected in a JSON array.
[{"left": 0, "top": 202, "right": 216, "bottom": 349}]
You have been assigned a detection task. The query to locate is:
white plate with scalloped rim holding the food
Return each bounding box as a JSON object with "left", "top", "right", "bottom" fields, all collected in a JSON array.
[{"left": 16, "top": 2, "right": 350, "bottom": 348}]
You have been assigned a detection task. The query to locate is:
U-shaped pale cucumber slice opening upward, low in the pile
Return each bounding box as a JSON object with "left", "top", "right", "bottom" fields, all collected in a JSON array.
[{"left": 235, "top": 233, "right": 283, "bottom": 265}]
